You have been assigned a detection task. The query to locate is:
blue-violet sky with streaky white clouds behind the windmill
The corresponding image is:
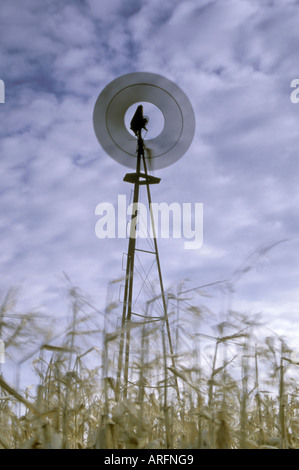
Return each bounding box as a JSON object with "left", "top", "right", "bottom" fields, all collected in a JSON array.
[{"left": 0, "top": 0, "right": 299, "bottom": 384}]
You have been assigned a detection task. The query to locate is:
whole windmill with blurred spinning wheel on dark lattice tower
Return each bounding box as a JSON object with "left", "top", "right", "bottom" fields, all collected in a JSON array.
[{"left": 93, "top": 72, "right": 195, "bottom": 397}]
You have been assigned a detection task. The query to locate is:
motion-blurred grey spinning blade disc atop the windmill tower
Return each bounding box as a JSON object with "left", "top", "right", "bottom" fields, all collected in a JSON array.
[{"left": 93, "top": 72, "right": 195, "bottom": 170}]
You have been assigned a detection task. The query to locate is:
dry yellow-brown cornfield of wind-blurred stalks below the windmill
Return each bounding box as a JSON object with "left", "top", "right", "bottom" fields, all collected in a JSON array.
[{"left": 0, "top": 258, "right": 299, "bottom": 449}]
